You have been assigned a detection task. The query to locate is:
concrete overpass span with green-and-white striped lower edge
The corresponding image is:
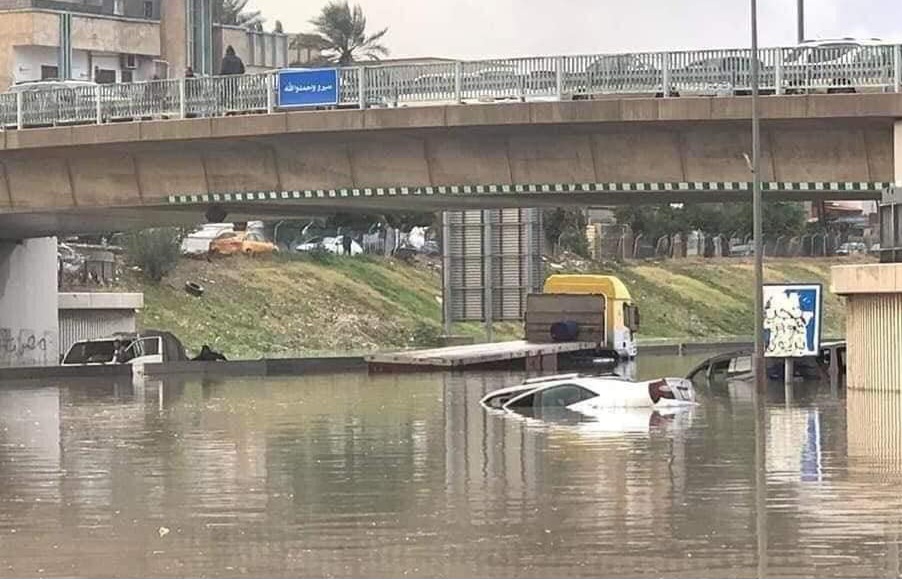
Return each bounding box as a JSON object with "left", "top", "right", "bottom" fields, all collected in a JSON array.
[{"left": 0, "top": 93, "right": 902, "bottom": 239}]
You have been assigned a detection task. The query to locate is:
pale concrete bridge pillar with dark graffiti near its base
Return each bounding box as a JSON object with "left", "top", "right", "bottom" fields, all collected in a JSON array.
[{"left": 0, "top": 237, "right": 59, "bottom": 368}]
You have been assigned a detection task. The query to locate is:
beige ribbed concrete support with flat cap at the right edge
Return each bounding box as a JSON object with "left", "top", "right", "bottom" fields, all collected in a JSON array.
[{"left": 831, "top": 263, "right": 902, "bottom": 393}]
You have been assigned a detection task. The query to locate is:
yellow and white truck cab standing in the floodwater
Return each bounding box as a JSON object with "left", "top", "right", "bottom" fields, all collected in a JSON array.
[{"left": 543, "top": 274, "right": 639, "bottom": 358}]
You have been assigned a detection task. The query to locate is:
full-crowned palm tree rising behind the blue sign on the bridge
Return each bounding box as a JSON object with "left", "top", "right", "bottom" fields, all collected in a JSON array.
[{"left": 311, "top": 0, "right": 388, "bottom": 65}]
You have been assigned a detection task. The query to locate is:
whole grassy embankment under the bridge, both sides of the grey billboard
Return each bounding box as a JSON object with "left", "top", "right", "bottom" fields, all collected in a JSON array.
[{"left": 120, "top": 255, "right": 860, "bottom": 358}]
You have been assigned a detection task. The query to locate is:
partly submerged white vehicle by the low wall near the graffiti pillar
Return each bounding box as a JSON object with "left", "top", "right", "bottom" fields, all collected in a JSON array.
[{"left": 62, "top": 330, "right": 188, "bottom": 366}]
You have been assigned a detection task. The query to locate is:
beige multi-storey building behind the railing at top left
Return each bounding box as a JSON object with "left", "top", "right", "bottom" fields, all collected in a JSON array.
[{"left": 0, "top": 0, "right": 289, "bottom": 91}]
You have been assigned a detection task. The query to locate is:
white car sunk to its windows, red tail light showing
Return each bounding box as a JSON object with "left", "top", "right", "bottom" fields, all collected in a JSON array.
[{"left": 481, "top": 374, "right": 695, "bottom": 416}]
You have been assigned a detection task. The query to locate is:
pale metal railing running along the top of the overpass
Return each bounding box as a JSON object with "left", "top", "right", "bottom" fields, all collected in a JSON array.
[{"left": 0, "top": 43, "right": 902, "bottom": 129}]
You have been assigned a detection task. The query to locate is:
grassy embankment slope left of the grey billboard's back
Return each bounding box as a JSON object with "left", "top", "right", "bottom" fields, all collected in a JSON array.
[{"left": 115, "top": 254, "right": 519, "bottom": 358}]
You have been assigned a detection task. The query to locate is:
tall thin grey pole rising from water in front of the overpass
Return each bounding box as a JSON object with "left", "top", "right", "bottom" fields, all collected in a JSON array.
[{"left": 751, "top": 0, "right": 767, "bottom": 393}]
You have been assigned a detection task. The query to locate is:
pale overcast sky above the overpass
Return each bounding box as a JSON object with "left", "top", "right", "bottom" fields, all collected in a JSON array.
[{"left": 248, "top": 0, "right": 902, "bottom": 59}]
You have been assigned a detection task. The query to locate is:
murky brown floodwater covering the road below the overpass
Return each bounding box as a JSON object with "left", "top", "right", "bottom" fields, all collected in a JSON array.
[{"left": 0, "top": 358, "right": 902, "bottom": 577}]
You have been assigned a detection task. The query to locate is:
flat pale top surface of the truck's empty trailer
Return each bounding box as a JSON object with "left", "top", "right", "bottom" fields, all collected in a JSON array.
[{"left": 366, "top": 340, "right": 596, "bottom": 369}]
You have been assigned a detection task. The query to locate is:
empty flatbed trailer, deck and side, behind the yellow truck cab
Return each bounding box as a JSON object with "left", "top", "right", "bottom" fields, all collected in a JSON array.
[{"left": 366, "top": 340, "right": 598, "bottom": 372}]
